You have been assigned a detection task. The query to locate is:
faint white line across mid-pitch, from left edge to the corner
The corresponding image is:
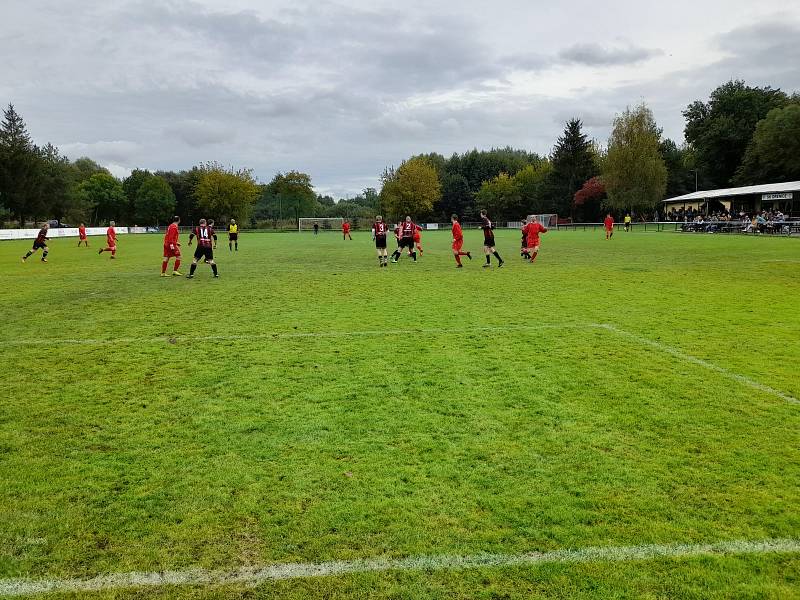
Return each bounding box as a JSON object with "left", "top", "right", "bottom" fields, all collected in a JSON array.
[{"left": 0, "top": 323, "right": 604, "bottom": 346}]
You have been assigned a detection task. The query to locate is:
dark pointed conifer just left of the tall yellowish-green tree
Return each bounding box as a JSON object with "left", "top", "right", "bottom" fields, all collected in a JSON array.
[{"left": 543, "top": 119, "right": 598, "bottom": 215}]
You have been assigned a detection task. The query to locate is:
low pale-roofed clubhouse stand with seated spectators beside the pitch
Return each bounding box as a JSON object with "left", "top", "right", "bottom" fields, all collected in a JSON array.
[{"left": 664, "top": 181, "right": 800, "bottom": 216}]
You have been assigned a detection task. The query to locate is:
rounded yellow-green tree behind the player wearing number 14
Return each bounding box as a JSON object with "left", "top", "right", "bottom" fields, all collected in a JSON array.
[{"left": 194, "top": 163, "right": 259, "bottom": 223}]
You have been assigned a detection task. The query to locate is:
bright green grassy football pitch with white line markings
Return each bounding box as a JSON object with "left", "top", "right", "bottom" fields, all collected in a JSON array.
[{"left": 0, "top": 231, "right": 800, "bottom": 599}]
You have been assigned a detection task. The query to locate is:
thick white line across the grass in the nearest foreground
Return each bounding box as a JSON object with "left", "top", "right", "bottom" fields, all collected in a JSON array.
[{"left": 0, "top": 539, "right": 800, "bottom": 596}]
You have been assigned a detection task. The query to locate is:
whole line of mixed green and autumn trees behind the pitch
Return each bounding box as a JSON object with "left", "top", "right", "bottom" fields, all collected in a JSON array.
[{"left": 0, "top": 81, "right": 800, "bottom": 227}]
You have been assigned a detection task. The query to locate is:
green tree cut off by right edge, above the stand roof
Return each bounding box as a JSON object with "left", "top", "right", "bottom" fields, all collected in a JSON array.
[{"left": 735, "top": 104, "right": 800, "bottom": 185}]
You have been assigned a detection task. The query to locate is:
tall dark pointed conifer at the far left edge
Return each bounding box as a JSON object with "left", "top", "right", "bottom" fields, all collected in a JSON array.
[{"left": 0, "top": 104, "right": 41, "bottom": 227}]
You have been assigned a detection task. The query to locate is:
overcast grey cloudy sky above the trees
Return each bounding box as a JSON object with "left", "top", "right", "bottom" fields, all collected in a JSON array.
[{"left": 0, "top": 0, "right": 800, "bottom": 197}]
